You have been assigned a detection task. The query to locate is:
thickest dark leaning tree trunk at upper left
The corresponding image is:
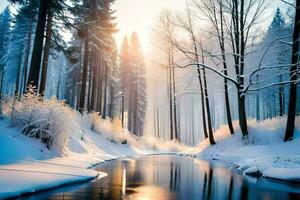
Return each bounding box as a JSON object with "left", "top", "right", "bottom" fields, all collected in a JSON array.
[{"left": 27, "top": 0, "right": 49, "bottom": 87}]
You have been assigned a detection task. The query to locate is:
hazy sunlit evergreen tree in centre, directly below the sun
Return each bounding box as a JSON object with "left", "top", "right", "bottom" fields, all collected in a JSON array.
[{"left": 120, "top": 32, "right": 147, "bottom": 136}]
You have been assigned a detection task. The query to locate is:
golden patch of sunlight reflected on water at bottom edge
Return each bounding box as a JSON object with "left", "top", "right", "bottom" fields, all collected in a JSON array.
[{"left": 126, "top": 185, "right": 175, "bottom": 200}]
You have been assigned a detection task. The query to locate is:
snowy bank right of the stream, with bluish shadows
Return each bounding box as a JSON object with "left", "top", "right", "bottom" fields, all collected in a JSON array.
[{"left": 197, "top": 117, "right": 300, "bottom": 183}]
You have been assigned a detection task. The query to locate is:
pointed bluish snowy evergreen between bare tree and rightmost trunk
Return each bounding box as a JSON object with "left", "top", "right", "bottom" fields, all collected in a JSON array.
[{"left": 256, "top": 8, "right": 291, "bottom": 120}]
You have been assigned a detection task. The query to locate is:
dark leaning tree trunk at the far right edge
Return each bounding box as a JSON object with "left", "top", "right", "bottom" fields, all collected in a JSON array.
[{"left": 284, "top": 0, "right": 300, "bottom": 141}]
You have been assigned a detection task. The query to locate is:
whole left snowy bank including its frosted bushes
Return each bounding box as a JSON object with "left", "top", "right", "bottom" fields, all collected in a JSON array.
[{"left": 0, "top": 97, "right": 187, "bottom": 199}]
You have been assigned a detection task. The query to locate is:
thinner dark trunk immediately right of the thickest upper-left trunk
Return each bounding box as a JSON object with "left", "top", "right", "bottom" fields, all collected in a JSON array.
[{"left": 39, "top": 3, "right": 52, "bottom": 95}]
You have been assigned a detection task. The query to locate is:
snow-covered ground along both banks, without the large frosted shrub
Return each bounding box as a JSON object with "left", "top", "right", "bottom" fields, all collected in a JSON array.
[{"left": 0, "top": 112, "right": 300, "bottom": 199}]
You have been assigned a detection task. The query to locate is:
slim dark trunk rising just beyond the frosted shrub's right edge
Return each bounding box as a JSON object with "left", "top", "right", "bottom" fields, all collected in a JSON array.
[{"left": 79, "top": 31, "right": 89, "bottom": 114}]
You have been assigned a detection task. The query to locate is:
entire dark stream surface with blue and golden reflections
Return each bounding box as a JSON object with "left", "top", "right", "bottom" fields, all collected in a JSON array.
[{"left": 19, "top": 156, "right": 300, "bottom": 200}]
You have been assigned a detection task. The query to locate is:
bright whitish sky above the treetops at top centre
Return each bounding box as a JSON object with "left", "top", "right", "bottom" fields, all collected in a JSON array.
[{"left": 0, "top": 0, "right": 288, "bottom": 53}]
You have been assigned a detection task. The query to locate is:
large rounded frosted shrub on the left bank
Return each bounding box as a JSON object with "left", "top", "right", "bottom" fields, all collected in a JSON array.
[{"left": 9, "top": 90, "right": 77, "bottom": 154}]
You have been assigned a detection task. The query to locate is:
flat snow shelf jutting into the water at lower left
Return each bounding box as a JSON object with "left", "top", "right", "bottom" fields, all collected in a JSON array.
[{"left": 0, "top": 162, "right": 106, "bottom": 199}]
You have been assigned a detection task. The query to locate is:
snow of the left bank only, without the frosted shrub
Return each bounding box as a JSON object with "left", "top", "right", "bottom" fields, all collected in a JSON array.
[{"left": 0, "top": 116, "right": 188, "bottom": 199}]
